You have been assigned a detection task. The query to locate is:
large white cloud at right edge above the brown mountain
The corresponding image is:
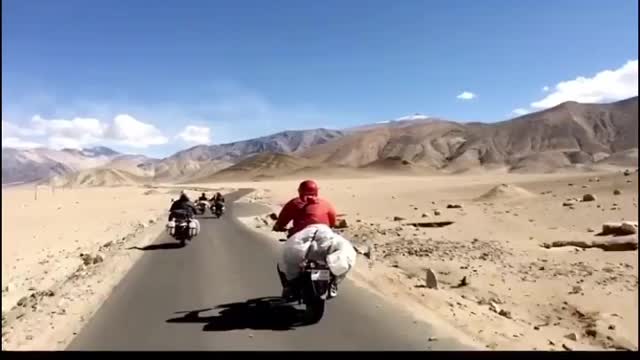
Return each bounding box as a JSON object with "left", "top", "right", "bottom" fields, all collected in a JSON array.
[{"left": 531, "top": 59, "right": 638, "bottom": 109}]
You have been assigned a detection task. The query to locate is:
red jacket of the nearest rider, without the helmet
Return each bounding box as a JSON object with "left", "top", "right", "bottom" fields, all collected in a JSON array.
[{"left": 273, "top": 197, "right": 336, "bottom": 237}]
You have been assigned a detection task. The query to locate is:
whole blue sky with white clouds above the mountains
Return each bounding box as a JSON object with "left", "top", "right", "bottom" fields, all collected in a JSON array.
[{"left": 2, "top": 0, "right": 638, "bottom": 156}]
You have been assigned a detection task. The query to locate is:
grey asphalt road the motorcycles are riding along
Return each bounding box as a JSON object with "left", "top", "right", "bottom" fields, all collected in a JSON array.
[{"left": 68, "top": 190, "right": 465, "bottom": 350}]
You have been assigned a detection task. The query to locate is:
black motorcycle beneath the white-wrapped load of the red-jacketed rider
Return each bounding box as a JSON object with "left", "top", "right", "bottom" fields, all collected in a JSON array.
[{"left": 277, "top": 239, "right": 335, "bottom": 324}]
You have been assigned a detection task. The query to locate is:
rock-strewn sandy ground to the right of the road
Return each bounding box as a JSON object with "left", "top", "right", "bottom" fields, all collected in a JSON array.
[{"left": 208, "top": 172, "right": 638, "bottom": 350}]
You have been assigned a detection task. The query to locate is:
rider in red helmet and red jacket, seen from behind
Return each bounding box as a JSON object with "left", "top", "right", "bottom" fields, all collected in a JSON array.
[{"left": 273, "top": 180, "right": 336, "bottom": 237}]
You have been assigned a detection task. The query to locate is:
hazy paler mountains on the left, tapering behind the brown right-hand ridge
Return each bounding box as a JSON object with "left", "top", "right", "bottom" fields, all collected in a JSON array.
[{"left": 2, "top": 129, "right": 342, "bottom": 184}]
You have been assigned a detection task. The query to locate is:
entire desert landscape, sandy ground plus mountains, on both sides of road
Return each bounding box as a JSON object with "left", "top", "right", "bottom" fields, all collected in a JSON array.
[{"left": 2, "top": 96, "right": 638, "bottom": 350}]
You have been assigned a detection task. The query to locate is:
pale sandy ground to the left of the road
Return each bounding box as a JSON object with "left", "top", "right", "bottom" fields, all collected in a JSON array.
[{"left": 2, "top": 187, "right": 229, "bottom": 350}]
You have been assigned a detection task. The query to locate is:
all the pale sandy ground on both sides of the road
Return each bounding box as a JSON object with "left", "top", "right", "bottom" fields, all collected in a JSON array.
[{"left": 2, "top": 172, "right": 638, "bottom": 350}]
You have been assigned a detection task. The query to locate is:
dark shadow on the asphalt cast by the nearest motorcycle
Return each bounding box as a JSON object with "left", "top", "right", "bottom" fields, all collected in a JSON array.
[{"left": 167, "top": 297, "right": 305, "bottom": 331}]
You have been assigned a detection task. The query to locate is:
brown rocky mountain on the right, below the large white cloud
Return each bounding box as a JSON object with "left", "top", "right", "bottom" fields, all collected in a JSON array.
[{"left": 301, "top": 97, "right": 638, "bottom": 172}]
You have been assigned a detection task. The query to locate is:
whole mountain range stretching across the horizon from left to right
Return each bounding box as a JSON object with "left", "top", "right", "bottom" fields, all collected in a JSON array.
[{"left": 2, "top": 97, "right": 638, "bottom": 186}]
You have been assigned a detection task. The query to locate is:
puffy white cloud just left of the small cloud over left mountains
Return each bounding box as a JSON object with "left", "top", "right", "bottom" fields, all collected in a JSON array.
[{"left": 106, "top": 114, "right": 169, "bottom": 148}]
